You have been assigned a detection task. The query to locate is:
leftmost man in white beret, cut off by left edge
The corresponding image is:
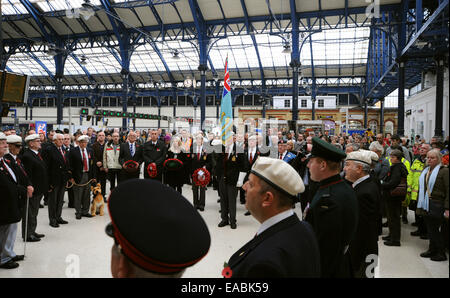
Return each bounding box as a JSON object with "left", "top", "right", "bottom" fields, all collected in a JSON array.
[{"left": 0, "top": 132, "right": 21, "bottom": 269}]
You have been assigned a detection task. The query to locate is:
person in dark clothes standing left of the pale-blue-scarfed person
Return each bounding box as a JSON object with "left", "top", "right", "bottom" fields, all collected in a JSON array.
[{"left": 381, "top": 149, "right": 408, "bottom": 246}]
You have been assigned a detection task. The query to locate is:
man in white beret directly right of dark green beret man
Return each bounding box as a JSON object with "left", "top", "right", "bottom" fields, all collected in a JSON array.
[{"left": 344, "top": 150, "right": 381, "bottom": 278}]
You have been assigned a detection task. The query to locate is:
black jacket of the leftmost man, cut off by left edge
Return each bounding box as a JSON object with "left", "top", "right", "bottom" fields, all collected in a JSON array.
[{"left": 0, "top": 158, "right": 21, "bottom": 225}]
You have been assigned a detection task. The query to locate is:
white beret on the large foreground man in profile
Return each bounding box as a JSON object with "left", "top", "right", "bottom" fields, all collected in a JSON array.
[{"left": 251, "top": 157, "right": 305, "bottom": 196}]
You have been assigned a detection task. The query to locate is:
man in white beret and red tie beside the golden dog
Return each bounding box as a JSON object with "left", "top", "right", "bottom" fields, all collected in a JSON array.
[{"left": 68, "top": 135, "right": 96, "bottom": 220}]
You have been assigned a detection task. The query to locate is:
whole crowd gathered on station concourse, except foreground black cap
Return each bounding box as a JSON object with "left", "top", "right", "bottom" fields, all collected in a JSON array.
[{"left": 0, "top": 128, "right": 449, "bottom": 277}]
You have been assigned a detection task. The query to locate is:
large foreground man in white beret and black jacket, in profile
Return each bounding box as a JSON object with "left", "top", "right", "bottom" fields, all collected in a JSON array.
[{"left": 228, "top": 157, "right": 320, "bottom": 278}]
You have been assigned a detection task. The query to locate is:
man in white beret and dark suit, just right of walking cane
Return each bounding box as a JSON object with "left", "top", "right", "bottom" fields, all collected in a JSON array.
[{"left": 22, "top": 134, "right": 48, "bottom": 242}]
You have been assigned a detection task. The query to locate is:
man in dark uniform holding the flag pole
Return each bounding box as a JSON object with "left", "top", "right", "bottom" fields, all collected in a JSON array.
[{"left": 216, "top": 137, "right": 244, "bottom": 229}]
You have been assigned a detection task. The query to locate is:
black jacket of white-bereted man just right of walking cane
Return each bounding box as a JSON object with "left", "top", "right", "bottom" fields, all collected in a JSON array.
[{"left": 22, "top": 149, "right": 48, "bottom": 195}]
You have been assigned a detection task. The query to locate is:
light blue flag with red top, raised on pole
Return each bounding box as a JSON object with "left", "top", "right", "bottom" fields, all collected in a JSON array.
[{"left": 220, "top": 55, "right": 233, "bottom": 145}]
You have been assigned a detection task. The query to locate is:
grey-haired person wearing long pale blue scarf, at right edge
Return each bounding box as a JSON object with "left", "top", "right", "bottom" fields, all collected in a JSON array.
[{"left": 416, "top": 149, "right": 449, "bottom": 262}]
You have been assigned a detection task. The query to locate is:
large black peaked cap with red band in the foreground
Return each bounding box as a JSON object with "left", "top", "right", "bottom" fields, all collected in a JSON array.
[{"left": 107, "top": 179, "right": 211, "bottom": 274}]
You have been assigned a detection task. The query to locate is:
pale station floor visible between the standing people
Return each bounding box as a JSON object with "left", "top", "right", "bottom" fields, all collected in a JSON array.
[{"left": 0, "top": 186, "right": 449, "bottom": 278}]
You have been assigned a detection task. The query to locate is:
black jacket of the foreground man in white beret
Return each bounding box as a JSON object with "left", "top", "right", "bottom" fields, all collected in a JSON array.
[{"left": 228, "top": 214, "right": 320, "bottom": 278}]
